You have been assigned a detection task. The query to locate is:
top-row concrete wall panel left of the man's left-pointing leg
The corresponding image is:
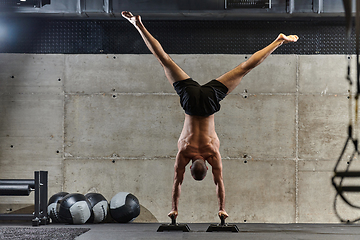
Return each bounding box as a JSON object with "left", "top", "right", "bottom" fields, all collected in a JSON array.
[{"left": 65, "top": 54, "right": 174, "bottom": 94}]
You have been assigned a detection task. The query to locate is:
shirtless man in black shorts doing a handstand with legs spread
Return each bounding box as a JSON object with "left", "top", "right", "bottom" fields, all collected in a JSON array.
[{"left": 121, "top": 12, "right": 298, "bottom": 221}]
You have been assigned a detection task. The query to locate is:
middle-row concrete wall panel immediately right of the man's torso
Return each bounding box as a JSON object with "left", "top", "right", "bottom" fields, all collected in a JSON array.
[{"left": 215, "top": 95, "right": 296, "bottom": 160}]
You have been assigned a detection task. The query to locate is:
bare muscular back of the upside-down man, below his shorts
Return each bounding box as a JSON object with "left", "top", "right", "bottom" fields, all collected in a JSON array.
[{"left": 178, "top": 114, "right": 220, "bottom": 165}]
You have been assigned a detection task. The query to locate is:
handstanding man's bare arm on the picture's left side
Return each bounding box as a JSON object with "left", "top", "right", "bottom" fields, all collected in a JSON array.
[{"left": 168, "top": 153, "right": 190, "bottom": 218}]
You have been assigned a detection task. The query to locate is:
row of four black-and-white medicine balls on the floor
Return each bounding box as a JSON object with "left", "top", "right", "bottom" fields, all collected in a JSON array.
[{"left": 48, "top": 192, "right": 140, "bottom": 224}]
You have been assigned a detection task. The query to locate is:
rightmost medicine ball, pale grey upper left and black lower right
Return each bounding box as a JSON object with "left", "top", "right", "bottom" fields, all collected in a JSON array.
[{"left": 110, "top": 192, "right": 140, "bottom": 223}]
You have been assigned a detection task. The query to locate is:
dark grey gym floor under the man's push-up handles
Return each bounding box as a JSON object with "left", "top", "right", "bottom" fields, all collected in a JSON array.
[{"left": 0, "top": 223, "right": 360, "bottom": 240}]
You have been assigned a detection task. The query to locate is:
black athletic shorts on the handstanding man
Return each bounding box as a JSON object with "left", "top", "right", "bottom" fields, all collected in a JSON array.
[{"left": 173, "top": 78, "right": 228, "bottom": 116}]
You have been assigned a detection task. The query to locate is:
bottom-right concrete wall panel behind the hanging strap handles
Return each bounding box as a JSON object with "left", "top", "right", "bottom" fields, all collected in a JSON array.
[{"left": 298, "top": 160, "right": 360, "bottom": 223}]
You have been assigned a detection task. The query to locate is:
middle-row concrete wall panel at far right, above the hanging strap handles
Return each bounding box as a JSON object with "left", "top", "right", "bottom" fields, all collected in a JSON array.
[{"left": 299, "top": 95, "right": 351, "bottom": 160}]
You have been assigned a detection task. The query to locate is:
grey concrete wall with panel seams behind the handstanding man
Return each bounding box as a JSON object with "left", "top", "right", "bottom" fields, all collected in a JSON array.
[{"left": 0, "top": 54, "right": 360, "bottom": 223}]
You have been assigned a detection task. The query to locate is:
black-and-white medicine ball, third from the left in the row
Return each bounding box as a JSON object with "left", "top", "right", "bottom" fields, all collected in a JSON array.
[{"left": 85, "top": 193, "right": 109, "bottom": 223}]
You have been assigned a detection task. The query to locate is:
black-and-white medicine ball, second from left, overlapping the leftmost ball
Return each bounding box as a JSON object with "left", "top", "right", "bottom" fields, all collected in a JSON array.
[{"left": 59, "top": 193, "right": 91, "bottom": 224}]
